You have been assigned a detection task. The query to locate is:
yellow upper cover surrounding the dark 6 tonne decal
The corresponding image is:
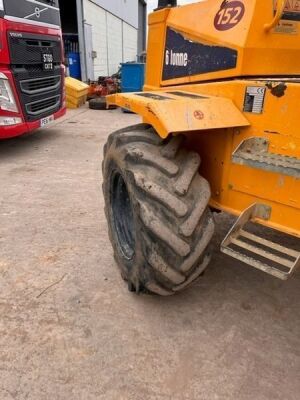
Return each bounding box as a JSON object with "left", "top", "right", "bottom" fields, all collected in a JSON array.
[{"left": 146, "top": 0, "right": 300, "bottom": 87}]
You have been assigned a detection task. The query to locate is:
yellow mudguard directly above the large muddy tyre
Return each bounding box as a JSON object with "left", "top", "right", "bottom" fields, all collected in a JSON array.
[{"left": 106, "top": 90, "right": 250, "bottom": 138}]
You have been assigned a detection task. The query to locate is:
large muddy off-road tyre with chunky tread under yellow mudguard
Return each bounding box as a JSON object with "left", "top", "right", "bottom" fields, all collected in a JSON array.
[{"left": 103, "top": 124, "right": 214, "bottom": 296}]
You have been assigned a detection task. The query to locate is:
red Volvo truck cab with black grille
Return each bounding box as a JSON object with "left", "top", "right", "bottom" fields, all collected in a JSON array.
[{"left": 0, "top": 0, "right": 66, "bottom": 139}]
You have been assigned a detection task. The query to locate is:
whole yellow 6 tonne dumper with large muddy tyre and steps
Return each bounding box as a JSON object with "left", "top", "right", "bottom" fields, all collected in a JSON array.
[{"left": 103, "top": 0, "right": 300, "bottom": 295}]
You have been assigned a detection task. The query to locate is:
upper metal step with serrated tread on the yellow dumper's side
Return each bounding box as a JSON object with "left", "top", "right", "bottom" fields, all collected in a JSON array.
[{"left": 232, "top": 137, "right": 300, "bottom": 178}]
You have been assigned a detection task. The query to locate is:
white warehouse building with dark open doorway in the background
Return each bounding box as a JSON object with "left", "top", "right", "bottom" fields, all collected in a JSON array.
[{"left": 60, "top": 0, "right": 147, "bottom": 81}]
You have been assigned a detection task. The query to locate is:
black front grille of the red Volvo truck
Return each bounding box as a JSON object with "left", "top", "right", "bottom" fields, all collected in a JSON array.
[{"left": 8, "top": 32, "right": 63, "bottom": 122}]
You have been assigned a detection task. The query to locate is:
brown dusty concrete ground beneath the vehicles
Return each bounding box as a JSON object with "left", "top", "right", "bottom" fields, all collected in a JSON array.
[{"left": 0, "top": 108, "right": 300, "bottom": 400}]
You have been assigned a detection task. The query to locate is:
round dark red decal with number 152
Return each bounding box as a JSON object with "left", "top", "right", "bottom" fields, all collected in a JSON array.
[{"left": 214, "top": 1, "right": 245, "bottom": 31}]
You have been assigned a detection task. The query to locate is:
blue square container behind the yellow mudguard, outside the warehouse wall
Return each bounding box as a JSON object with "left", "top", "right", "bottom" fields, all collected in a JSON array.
[{"left": 121, "top": 63, "right": 145, "bottom": 92}]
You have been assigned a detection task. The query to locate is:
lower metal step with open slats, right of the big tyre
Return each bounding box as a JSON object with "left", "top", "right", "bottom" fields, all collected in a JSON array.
[{"left": 221, "top": 203, "right": 300, "bottom": 280}]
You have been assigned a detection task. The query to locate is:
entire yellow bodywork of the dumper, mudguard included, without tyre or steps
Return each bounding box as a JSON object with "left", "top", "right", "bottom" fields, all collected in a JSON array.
[{"left": 110, "top": 0, "right": 300, "bottom": 237}]
